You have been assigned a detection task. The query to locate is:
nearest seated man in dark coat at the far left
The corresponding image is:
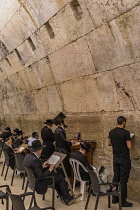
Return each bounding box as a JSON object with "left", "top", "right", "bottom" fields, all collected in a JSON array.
[{"left": 3, "top": 135, "right": 15, "bottom": 170}]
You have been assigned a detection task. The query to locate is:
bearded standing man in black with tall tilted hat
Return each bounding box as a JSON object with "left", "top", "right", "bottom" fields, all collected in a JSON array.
[{"left": 53, "top": 112, "right": 73, "bottom": 177}]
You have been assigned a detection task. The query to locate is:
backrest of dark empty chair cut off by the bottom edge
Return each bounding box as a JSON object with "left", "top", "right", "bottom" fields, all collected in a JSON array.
[{"left": 8, "top": 193, "right": 25, "bottom": 210}]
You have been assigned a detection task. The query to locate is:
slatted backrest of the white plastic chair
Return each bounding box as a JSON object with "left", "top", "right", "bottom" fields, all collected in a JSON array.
[{"left": 69, "top": 158, "right": 88, "bottom": 181}]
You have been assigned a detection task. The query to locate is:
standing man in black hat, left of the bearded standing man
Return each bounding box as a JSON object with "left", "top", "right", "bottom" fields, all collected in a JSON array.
[{"left": 41, "top": 119, "right": 55, "bottom": 159}]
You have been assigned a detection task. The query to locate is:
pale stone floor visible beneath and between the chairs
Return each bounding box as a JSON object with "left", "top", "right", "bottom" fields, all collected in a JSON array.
[{"left": 0, "top": 153, "right": 140, "bottom": 210}]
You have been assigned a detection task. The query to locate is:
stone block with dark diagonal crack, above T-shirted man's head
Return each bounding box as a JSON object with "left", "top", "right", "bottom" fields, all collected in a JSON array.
[{"left": 113, "top": 63, "right": 140, "bottom": 110}]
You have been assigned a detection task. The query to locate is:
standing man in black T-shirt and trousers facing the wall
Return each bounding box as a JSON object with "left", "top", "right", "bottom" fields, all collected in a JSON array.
[{"left": 108, "top": 116, "right": 133, "bottom": 207}]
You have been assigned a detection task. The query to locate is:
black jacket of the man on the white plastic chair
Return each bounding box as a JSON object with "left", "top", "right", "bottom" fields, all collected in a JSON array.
[{"left": 71, "top": 151, "right": 93, "bottom": 180}]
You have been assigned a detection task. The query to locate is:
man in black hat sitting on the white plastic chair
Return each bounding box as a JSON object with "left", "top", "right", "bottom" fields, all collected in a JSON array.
[{"left": 71, "top": 142, "right": 93, "bottom": 181}]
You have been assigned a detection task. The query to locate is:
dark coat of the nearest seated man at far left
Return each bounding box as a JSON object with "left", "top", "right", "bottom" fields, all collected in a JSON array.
[{"left": 3, "top": 144, "right": 15, "bottom": 170}]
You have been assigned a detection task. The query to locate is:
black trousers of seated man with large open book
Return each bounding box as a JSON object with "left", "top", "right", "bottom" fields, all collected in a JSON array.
[{"left": 48, "top": 169, "right": 69, "bottom": 199}]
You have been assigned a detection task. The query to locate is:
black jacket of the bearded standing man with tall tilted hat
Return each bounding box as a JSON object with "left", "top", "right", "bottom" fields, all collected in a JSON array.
[{"left": 54, "top": 126, "right": 72, "bottom": 153}]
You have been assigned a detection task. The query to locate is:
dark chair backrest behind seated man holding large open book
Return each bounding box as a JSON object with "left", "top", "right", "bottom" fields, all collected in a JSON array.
[{"left": 24, "top": 166, "right": 36, "bottom": 191}]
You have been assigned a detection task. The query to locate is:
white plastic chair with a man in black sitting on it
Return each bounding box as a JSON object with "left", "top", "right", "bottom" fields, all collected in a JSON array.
[{"left": 69, "top": 158, "right": 90, "bottom": 200}]
